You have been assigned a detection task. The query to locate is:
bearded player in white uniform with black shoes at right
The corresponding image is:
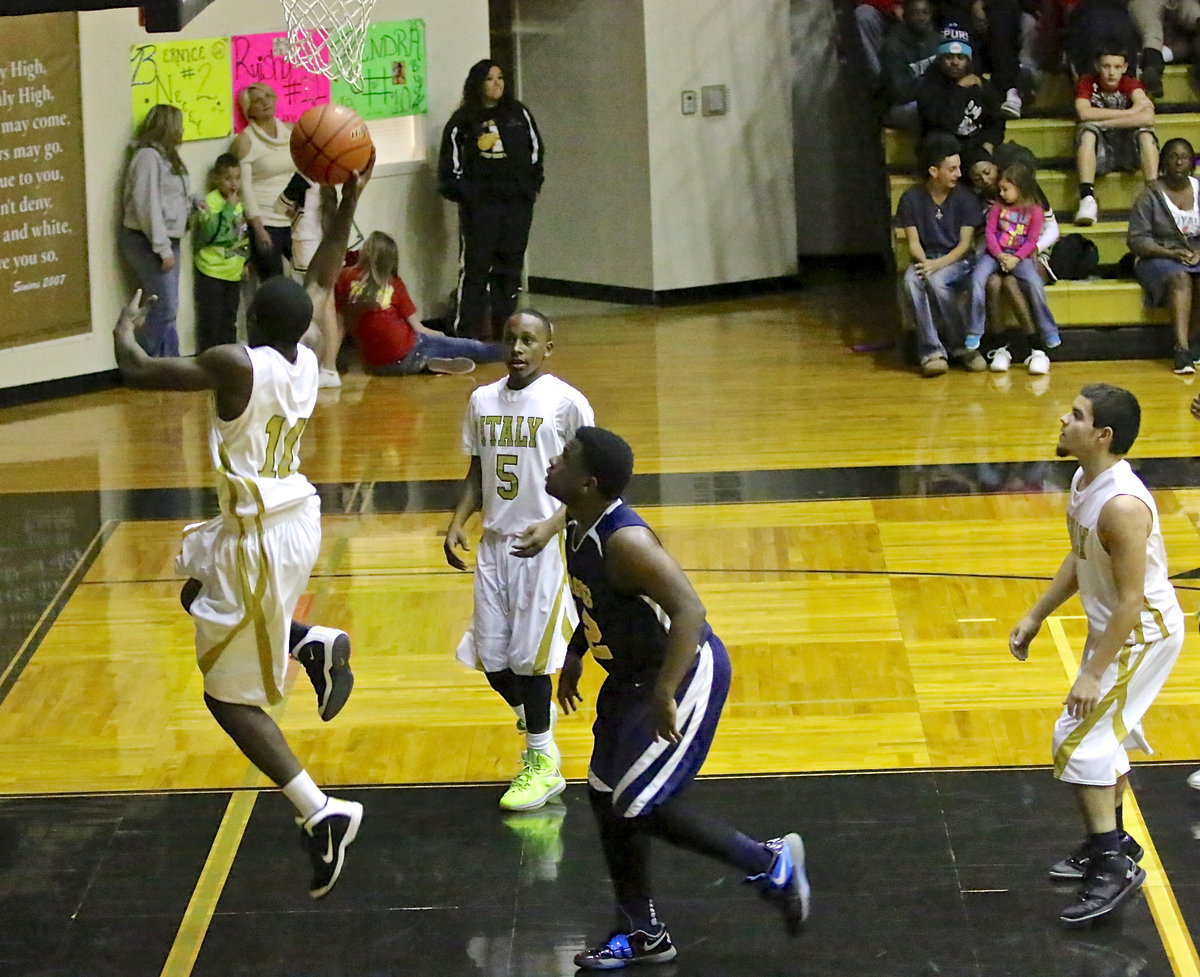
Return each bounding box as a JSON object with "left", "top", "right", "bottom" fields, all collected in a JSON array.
[{"left": 1009, "top": 383, "right": 1183, "bottom": 925}]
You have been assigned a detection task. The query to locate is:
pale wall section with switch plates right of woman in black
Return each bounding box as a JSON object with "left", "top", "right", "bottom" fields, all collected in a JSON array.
[{"left": 517, "top": 0, "right": 796, "bottom": 290}]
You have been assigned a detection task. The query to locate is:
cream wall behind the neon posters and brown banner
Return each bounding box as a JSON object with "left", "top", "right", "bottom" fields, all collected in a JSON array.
[{"left": 0, "top": 0, "right": 488, "bottom": 389}]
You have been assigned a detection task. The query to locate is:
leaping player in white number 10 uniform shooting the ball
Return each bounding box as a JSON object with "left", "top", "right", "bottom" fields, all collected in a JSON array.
[{"left": 114, "top": 170, "right": 362, "bottom": 899}]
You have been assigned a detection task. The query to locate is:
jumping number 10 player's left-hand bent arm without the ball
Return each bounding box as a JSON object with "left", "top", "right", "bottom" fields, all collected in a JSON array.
[{"left": 113, "top": 289, "right": 253, "bottom": 416}]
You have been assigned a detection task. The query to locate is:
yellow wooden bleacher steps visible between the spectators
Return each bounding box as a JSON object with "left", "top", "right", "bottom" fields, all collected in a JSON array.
[{"left": 883, "top": 65, "right": 1200, "bottom": 348}]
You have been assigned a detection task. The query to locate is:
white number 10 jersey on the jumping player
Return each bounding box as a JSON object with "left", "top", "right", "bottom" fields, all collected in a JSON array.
[{"left": 209, "top": 344, "right": 317, "bottom": 517}]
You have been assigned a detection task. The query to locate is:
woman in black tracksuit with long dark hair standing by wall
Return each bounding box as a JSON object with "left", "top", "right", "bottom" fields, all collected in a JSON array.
[{"left": 438, "top": 59, "right": 545, "bottom": 340}]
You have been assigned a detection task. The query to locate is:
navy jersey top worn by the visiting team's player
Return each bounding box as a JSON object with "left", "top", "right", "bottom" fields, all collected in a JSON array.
[{"left": 566, "top": 499, "right": 712, "bottom": 682}]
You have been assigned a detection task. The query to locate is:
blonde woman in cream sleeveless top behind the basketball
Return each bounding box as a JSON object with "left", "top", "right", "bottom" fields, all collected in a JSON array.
[{"left": 233, "top": 82, "right": 295, "bottom": 278}]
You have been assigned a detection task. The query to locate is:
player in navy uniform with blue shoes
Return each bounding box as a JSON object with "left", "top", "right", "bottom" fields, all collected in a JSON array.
[{"left": 546, "top": 426, "right": 809, "bottom": 970}]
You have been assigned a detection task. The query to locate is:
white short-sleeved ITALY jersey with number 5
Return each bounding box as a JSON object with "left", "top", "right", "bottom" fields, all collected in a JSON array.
[{"left": 462, "top": 373, "right": 595, "bottom": 535}]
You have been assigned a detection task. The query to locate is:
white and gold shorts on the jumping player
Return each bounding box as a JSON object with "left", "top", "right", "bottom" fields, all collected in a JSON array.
[{"left": 175, "top": 496, "right": 320, "bottom": 707}]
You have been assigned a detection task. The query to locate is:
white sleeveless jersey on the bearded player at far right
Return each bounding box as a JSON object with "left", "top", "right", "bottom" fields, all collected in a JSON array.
[{"left": 1067, "top": 461, "right": 1183, "bottom": 643}]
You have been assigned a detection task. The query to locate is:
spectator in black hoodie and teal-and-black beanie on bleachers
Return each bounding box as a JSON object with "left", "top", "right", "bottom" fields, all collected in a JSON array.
[{"left": 917, "top": 24, "right": 1004, "bottom": 155}]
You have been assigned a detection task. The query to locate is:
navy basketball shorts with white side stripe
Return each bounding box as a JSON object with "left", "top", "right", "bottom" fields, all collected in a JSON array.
[{"left": 588, "top": 635, "right": 730, "bottom": 817}]
